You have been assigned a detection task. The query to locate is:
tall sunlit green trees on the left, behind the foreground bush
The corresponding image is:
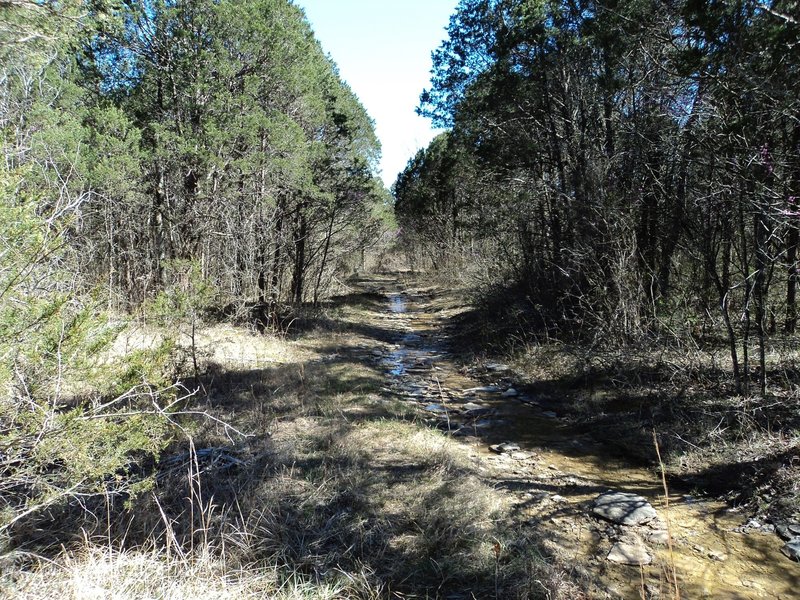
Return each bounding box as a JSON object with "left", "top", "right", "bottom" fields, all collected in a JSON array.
[{"left": 0, "top": 0, "right": 384, "bottom": 314}]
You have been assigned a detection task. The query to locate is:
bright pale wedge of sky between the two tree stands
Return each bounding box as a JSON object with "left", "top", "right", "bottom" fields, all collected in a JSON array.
[{"left": 294, "top": 0, "right": 458, "bottom": 187}]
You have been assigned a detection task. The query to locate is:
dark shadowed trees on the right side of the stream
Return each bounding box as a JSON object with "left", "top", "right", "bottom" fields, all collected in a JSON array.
[{"left": 395, "top": 0, "right": 800, "bottom": 391}]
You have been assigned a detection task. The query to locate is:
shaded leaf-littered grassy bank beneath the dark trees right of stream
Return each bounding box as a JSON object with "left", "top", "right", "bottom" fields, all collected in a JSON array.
[{"left": 496, "top": 342, "right": 800, "bottom": 520}]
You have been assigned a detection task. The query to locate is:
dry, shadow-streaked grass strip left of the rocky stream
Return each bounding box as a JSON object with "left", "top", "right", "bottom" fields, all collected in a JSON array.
[{"left": 2, "top": 282, "right": 580, "bottom": 598}]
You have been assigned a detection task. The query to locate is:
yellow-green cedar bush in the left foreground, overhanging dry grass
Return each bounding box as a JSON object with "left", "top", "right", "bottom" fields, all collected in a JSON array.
[{"left": 0, "top": 163, "right": 171, "bottom": 530}]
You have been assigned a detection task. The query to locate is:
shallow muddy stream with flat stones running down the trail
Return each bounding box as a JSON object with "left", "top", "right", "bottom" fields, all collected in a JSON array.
[{"left": 382, "top": 293, "right": 800, "bottom": 599}]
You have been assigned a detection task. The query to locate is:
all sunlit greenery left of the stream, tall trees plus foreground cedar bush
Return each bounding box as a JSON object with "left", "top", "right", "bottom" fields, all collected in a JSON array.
[{"left": 0, "top": 0, "right": 387, "bottom": 540}]
